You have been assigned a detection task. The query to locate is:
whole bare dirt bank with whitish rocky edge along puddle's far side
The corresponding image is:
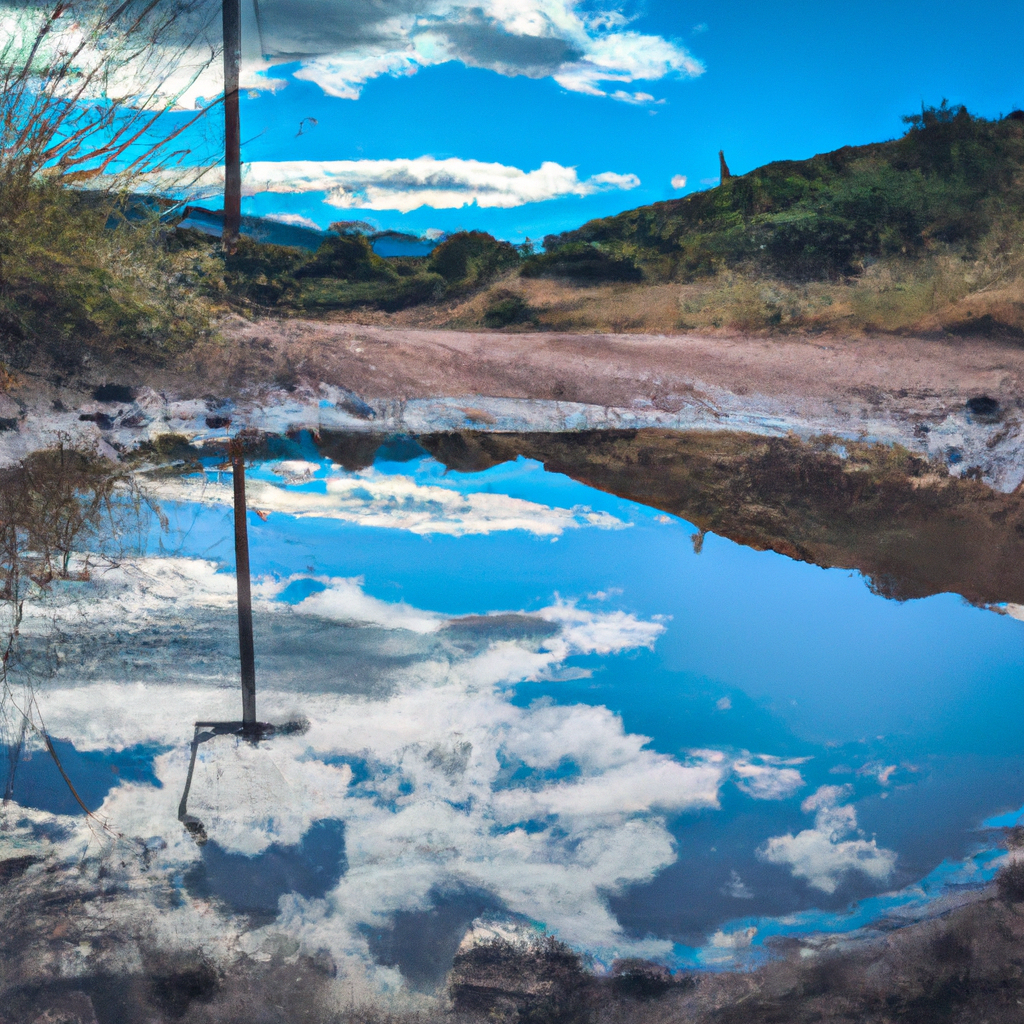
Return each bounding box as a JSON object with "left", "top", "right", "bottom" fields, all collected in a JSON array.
[{"left": 0, "top": 321, "right": 1024, "bottom": 493}]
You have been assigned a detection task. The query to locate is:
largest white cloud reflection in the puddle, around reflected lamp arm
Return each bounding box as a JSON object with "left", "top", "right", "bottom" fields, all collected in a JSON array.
[{"left": 22, "top": 571, "right": 729, "bottom": 966}]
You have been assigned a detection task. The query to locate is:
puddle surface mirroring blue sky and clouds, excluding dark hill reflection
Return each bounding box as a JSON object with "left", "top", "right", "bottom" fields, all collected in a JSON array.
[{"left": 2, "top": 428, "right": 1024, "bottom": 1003}]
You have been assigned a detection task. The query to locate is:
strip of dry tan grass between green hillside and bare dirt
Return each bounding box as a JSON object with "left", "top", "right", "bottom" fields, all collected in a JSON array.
[{"left": 292, "top": 247, "right": 1024, "bottom": 338}]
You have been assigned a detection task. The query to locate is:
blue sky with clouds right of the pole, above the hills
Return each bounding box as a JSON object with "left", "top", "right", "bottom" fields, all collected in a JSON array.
[{"left": 169, "top": 0, "right": 1024, "bottom": 241}]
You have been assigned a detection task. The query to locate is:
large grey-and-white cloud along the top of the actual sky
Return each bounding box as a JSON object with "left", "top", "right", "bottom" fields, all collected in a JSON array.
[{"left": 0, "top": 0, "right": 703, "bottom": 115}]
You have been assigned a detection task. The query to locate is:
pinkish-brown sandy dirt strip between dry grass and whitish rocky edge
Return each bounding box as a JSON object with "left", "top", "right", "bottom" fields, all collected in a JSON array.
[{"left": 218, "top": 321, "right": 1024, "bottom": 415}]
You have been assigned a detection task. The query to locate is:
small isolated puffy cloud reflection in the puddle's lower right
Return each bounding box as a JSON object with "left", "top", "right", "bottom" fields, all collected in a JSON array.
[{"left": 758, "top": 785, "right": 896, "bottom": 893}]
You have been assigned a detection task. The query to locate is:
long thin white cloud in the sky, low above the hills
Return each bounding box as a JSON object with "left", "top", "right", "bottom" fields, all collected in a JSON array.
[{"left": 164, "top": 157, "right": 640, "bottom": 209}]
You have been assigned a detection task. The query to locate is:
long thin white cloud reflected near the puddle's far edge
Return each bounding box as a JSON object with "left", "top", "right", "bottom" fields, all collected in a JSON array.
[{"left": 148, "top": 468, "right": 630, "bottom": 537}]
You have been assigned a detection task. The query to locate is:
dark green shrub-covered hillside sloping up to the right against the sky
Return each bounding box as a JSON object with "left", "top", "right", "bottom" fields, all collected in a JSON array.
[{"left": 536, "top": 101, "right": 1024, "bottom": 282}]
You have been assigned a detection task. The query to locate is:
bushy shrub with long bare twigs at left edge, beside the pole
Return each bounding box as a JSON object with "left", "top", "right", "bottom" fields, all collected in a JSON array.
[{"left": 0, "top": 0, "right": 219, "bottom": 375}]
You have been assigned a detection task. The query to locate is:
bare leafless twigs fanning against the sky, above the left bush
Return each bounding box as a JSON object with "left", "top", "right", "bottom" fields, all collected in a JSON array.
[{"left": 0, "top": 0, "right": 216, "bottom": 193}]
